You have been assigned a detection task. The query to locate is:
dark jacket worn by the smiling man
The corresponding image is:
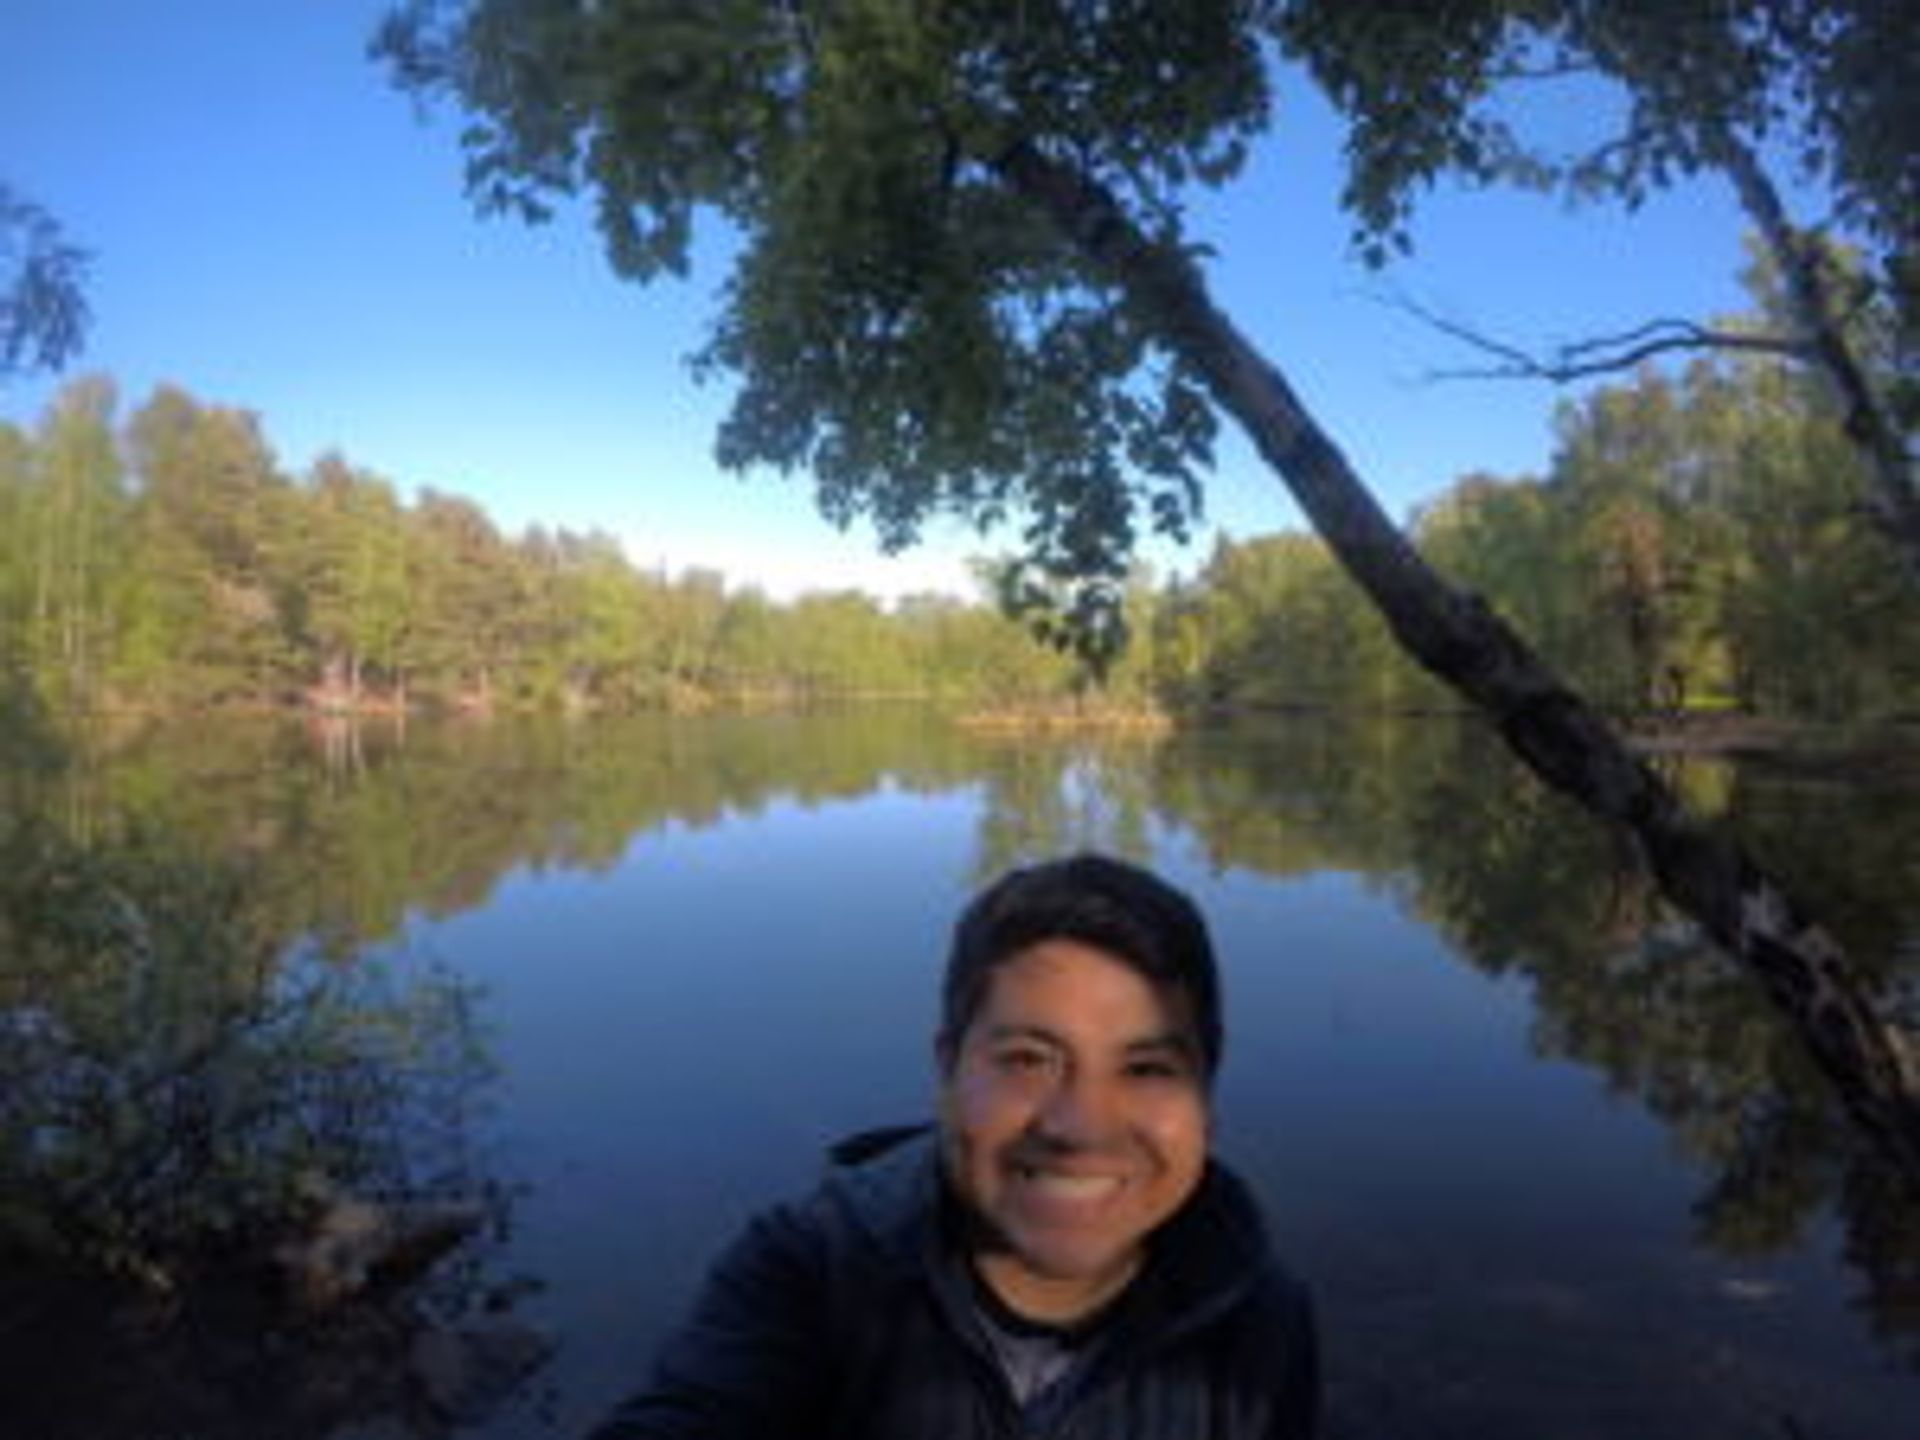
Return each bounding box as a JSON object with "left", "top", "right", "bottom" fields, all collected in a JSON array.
[{"left": 593, "top": 1129, "right": 1319, "bottom": 1440}]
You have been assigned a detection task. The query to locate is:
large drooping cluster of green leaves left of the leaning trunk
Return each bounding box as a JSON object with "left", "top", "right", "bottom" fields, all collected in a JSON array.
[{"left": 380, "top": 0, "right": 1269, "bottom": 657}]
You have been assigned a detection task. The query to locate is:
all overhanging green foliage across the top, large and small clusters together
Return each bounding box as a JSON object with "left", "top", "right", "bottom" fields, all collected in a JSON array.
[{"left": 376, "top": 0, "right": 1920, "bottom": 633}]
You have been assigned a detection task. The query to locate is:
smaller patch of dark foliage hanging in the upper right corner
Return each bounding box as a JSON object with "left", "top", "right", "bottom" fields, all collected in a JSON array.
[{"left": 1273, "top": 0, "right": 1920, "bottom": 257}]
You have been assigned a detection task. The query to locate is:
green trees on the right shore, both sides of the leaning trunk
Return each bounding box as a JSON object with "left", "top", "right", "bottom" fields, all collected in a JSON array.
[{"left": 1156, "top": 339, "right": 1920, "bottom": 720}]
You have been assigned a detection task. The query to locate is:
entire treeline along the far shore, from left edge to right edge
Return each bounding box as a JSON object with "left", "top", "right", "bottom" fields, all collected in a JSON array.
[{"left": 0, "top": 336, "right": 1920, "bottom": 718}]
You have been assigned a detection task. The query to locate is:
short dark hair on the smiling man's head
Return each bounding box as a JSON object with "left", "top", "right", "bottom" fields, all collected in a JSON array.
[{"left": 939, "top": 854, "right": 1223, "bottom": 1075}]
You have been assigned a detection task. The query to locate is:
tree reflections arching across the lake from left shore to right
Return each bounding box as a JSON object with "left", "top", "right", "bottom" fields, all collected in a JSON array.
[{"left": 26, "top": 707, "right": 1920, "bottom": 1367}]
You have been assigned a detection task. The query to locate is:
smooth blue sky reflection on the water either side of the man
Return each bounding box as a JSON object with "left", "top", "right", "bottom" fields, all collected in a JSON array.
[{"left": 408, "top": 789, "right": 1912, "bottom": 1440}]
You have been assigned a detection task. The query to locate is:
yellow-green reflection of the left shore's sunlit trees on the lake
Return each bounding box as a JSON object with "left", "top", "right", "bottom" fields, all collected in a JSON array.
[{"left": 61, "top": 707, "right": 998, "bottom": 954}]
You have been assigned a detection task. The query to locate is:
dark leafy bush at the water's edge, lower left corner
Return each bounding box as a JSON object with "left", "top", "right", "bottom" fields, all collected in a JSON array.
[{"left": 0, "top": 695, "right": 505, "bottom": 1440}]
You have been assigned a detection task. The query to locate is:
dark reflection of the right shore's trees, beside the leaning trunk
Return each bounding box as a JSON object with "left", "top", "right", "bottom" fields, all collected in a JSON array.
[{"left": 1160, "top": 724, "right": 1920, "bottom": 1367}]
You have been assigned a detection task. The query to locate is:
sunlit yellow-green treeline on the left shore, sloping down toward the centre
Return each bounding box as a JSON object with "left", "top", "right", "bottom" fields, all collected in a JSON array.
[{"left": 0, "top": 376, "right": 1128, "bottom": 708}]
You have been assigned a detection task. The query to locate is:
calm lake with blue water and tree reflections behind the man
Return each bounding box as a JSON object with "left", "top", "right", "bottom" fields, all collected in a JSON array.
[{"left": 0, "top": 708, "right": 1920, "bottom": 1440}]
